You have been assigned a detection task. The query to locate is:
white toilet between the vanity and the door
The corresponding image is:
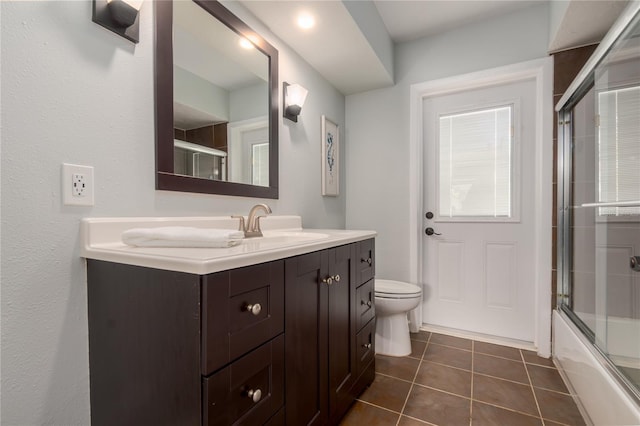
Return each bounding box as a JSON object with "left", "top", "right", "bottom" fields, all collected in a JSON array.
[{"left": 374, "top": 278, "right": 422, "bottom": 356}]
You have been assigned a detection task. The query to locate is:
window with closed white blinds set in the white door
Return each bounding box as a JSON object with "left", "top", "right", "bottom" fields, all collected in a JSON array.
[{"left": 437, "top": 105, "right": 514, "bottom": 221}]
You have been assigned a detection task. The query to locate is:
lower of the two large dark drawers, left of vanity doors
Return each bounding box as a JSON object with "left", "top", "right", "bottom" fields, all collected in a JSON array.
[{"left": 202, "top": 335, "right": 284, "bottom": 426}]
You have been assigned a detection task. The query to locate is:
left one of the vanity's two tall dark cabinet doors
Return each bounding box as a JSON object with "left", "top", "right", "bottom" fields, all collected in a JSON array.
[{"left": 285, "top": 250, "right": 329, "bottom": 426}]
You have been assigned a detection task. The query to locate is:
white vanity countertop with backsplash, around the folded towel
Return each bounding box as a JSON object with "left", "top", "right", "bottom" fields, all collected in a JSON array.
[{"left": 80, "top": 216, "right": 376, "bottom": 275}]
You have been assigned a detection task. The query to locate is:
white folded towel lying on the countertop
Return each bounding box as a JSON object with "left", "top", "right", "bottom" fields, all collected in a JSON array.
[{"left": 122, "top": 226, "right": 244, "bottom": 247}]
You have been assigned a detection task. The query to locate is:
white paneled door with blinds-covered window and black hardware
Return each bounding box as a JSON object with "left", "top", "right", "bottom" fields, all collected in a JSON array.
[{"left": 422, "top": 79, "right": 536, "bottom": 342}]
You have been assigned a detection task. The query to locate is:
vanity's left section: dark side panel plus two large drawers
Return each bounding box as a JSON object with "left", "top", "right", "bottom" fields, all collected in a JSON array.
[{"left": 87, "top": 260, "right": 284, "bottom": 426}]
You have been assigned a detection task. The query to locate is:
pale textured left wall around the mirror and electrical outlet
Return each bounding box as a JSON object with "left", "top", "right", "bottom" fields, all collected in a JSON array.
[{"left": 0, "top": 1, "right": 345, "bottom": 425}]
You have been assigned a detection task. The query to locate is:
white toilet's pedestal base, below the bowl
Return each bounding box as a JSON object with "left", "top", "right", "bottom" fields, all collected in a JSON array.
[{"left": 376, "top": 311, "right": 411, "bottom": 356}]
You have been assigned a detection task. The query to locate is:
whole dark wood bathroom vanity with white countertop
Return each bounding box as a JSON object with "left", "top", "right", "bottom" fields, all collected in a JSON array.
[{"left": 81, "top": 216, "right": 375, "bottom": 426}]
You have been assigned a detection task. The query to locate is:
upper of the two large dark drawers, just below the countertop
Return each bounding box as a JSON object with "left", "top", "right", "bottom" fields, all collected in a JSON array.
[{"left": 202, "top": 261, "right": 284, "bottom": 376}]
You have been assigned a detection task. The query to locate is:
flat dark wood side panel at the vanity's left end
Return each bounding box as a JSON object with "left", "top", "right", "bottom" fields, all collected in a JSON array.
[{"left": 87, "top": 260, "right": 201, "bottom": 426}]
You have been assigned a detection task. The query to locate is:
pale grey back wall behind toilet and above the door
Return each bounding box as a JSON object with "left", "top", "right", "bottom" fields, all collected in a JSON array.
[{"left": 346, "top": 4, "right": 551, "bottom": 280}]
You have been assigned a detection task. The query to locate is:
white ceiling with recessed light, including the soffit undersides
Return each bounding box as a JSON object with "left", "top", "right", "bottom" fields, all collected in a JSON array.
[{"left": 239, "top": 0, "right": 626, "bottom": 95}]
